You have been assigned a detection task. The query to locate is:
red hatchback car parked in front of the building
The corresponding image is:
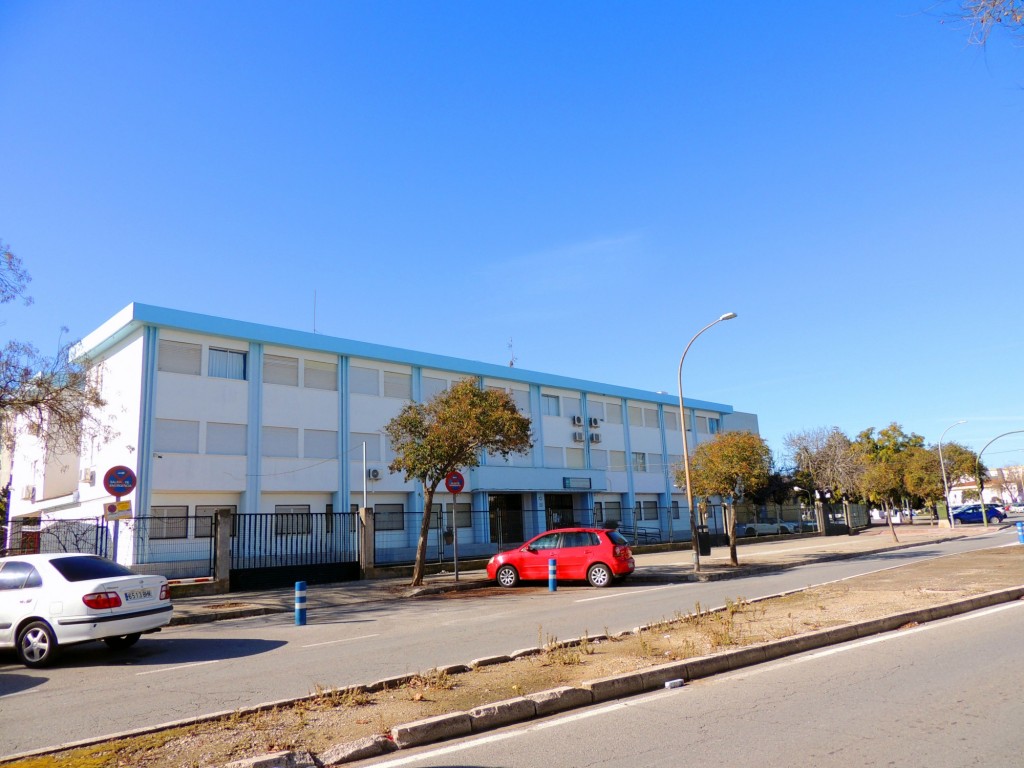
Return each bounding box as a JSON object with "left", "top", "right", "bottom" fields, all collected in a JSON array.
[{"left": 487, "top": 528, "right": 635, "bottom": 587}]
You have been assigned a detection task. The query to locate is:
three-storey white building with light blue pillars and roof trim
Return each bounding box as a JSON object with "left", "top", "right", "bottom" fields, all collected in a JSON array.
[{"left": 10, "top": 304, "right": 758, "bottom": 570}]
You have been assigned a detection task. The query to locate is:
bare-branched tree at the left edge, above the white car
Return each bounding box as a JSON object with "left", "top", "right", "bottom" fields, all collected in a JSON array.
[{"left": 0, "top": 243, "right": 109, "bottom": 454}]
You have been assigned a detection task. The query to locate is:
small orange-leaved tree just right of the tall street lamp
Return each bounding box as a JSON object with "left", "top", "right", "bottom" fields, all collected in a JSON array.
[{"left": 676, "top": 432, "right": 772, "bottom": 565}]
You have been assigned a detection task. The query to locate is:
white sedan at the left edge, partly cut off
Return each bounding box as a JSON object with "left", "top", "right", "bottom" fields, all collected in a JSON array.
[{"left": 0, "top": 553, "right": 173, "bottom": 667}]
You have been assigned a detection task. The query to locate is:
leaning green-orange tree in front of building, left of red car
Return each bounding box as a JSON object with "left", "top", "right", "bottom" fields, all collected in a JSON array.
[{"left": 384, "top": 379, "right": 532, "bottom": 587}]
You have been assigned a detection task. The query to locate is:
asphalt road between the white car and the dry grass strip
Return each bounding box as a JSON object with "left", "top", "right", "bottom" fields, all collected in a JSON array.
[{"left": 0, "top": 530, "right": 1016, "bottom": 755}]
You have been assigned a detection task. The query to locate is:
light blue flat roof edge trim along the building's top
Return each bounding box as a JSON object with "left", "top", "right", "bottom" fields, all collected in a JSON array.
[{"left": 81, "top": 304, "right": 733, "bottom": 414}]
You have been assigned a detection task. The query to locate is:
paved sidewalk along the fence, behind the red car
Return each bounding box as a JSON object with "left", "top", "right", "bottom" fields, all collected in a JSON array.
[{"left": 171, "top": 521, "right": 999, "bottom": 626}]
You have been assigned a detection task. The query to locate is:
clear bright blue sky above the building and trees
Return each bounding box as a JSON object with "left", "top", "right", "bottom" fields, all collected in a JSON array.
[{"left": 0, "top": 0, "right": 1024, "bottom": 466}]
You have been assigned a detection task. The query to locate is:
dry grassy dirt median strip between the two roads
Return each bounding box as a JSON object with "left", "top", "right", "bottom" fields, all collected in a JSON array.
[{"left": 9, "top": 547, "right": 1024, "bottom": 768}]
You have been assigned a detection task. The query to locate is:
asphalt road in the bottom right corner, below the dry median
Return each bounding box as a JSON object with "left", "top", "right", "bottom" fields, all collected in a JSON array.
[{"left": 353, "top": 601, "right": 1024, "bottom": 768}]
